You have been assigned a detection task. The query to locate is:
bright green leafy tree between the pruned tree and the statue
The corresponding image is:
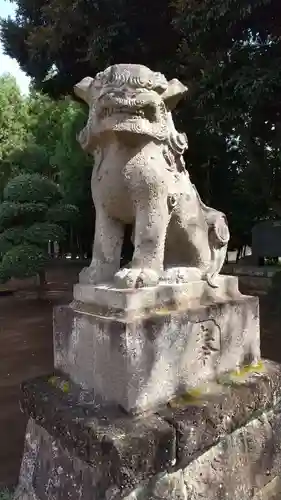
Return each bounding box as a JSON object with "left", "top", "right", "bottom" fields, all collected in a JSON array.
[{"left": 20, "top": 92, "right": 94, "bottom": 256}]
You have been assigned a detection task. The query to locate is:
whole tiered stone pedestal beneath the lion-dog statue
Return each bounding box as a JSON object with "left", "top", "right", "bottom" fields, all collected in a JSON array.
[{"left": 14, "top": 276, "right": 281, "bottom": 500}]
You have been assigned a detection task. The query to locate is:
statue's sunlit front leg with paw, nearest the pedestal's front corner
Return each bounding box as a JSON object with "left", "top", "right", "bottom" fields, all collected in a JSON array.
[{"left": 115, "top": 193, "right": 170, "bottom": 288}]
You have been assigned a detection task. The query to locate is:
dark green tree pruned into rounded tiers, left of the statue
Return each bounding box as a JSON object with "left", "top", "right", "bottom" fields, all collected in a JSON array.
[{"left": 0, "top": 174, "right": 76, "bottom": 285}]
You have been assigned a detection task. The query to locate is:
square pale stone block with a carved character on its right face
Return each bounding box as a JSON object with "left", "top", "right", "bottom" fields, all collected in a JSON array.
[{"left": 54, "top": 295, "right": 260, "bottom": 411}]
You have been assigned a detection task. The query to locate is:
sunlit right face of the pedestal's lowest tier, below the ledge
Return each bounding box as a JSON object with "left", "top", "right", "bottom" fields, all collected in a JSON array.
[{"left": 126, "top": 411, "right": 281, "bottom": 500}]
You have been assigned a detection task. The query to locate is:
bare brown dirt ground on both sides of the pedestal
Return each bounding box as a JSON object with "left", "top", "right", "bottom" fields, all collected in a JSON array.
[{"left": 0, "top": 265, "right": 281, "bottom": 490}]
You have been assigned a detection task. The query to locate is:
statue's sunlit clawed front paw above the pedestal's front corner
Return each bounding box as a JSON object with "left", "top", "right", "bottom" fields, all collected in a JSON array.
[{"left": 114, "top": 267, "right": 159, "bottom": 288}]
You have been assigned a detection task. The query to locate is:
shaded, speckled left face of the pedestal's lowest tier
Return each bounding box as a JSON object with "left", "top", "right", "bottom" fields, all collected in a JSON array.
[{"left": 15, "top": 419, "right": 115, "bottom": 500}]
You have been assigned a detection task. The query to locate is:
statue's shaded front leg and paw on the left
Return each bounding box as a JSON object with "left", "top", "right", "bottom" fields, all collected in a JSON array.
[{"left": 79, "top": 207, "right": 124, "bottom": 285}]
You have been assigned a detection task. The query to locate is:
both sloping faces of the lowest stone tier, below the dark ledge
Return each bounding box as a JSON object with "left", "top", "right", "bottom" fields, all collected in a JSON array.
[{"left": 15, "top": 412, "right": 281, "bottom": 500}]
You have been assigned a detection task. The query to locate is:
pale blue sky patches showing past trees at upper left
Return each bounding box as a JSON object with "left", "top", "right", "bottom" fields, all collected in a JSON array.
[{"left": 0, "top": 0, "right": 29, "bottom": 94}]
